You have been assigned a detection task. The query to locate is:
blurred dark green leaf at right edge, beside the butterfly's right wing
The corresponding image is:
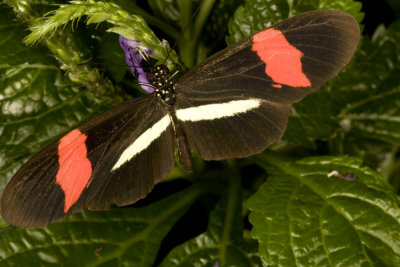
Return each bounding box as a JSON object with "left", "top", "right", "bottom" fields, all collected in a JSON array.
[{"left": 339, "top": 21, "right": 400, "bottom": 145}]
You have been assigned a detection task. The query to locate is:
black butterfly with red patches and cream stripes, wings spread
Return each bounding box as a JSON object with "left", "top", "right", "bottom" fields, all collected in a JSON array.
[{"left": 0, "top": 10, "right": 360, "bottom": 227}]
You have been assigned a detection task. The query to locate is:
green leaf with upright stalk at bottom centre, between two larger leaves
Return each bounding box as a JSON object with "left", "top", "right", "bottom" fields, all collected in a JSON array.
[{"left": 160, "top": 173, "right": 261, "bottom": 267}]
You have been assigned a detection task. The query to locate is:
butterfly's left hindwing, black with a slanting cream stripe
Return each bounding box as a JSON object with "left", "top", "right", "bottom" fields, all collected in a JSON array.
[{"left": 83, "top": 102, "right": 175, "bottom": 213}]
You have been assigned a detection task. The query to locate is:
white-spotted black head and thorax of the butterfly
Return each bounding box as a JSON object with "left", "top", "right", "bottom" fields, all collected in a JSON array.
[{"left": 147, "top": 65, "right": 176, "bottom": 106}]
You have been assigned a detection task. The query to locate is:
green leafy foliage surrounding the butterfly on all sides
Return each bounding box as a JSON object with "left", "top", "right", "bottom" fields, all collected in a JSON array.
[{"left": 0, "top": 0, "right": 400, "bottom": 266}]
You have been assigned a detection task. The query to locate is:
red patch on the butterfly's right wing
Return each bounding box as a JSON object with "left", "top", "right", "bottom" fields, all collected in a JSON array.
[{"left": 251, "top": 28, "right": 311, "bottom": 87}]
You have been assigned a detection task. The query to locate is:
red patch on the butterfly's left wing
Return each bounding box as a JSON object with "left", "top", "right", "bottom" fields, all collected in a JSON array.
[{"left": 56, "top": 129, "right": 92, "bottom": 212}]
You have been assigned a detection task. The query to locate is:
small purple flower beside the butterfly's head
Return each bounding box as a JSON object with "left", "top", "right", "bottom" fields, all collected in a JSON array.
[{"left": 119, "top": 36, "right": 154, "bottom": 93}]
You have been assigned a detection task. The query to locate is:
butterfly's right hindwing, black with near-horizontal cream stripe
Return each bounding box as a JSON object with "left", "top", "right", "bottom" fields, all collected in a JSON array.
[{"left": 176, "top": 97, "right": 290, "bottom": 160}]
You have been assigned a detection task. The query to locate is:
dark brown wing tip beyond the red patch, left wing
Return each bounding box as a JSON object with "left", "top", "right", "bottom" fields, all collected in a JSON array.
[{"left": 1, "top": 144, "right": 65, "bottom": 226}]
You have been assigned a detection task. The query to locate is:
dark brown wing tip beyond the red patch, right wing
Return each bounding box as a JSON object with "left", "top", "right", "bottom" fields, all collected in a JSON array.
[{"left": 274, "top": 10, "right": 360, "bottom": 90}]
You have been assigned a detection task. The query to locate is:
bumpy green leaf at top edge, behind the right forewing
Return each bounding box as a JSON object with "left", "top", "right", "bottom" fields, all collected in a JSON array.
[{"left": 226, "top": 0, "right": 363, "bottom": 44}]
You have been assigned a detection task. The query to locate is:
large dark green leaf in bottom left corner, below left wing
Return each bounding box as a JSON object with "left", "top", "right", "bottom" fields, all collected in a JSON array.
[{"left": 0, "top": 182, "right": 215, "bottom": 267}]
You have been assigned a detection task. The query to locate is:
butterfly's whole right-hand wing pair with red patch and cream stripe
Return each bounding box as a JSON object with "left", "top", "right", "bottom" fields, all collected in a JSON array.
[{"left": 175, "top": 10, "right": 360, "bottom": 160}]
